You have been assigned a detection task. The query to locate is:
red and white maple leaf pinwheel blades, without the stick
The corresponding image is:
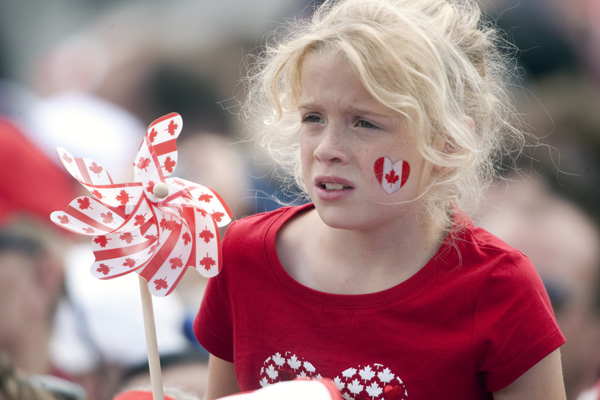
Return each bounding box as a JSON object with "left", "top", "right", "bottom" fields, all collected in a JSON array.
[{"left": 51, "top": 113, "right": 231, "bottom": 296}]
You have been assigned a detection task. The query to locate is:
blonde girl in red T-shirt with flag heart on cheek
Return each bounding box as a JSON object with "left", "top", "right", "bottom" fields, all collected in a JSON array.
[{"left": 195, "top": 0, "right": 565, "bottom": 399}]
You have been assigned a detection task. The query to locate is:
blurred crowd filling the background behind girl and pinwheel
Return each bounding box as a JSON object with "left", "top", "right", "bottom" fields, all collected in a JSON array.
[{"left": 0, "top": 0, "right": 600, "bottom": 400}]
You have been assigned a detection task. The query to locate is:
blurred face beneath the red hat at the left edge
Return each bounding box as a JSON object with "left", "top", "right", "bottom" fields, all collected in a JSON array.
[{"left": 0, "top": 216, "right": 64, "bottom": 375}]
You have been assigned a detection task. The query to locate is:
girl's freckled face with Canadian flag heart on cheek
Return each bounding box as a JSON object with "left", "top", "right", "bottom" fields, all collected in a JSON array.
[{"left": 298, "top": 52, "right": 429, "bottom": 230}]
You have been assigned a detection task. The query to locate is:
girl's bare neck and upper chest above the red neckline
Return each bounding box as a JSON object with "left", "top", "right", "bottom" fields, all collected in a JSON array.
[{"left": 278, "top": 206, "right": 445, "bottom": 294}]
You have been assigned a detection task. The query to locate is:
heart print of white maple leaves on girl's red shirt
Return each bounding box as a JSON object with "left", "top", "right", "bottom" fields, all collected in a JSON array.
[{"left": 260, "top": 351, "right": 408, "bottom": 400}]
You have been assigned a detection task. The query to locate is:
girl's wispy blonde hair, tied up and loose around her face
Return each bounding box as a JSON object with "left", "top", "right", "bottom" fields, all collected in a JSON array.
[{"left": 243, "top": 0, "right": 524, "bottom": 231}]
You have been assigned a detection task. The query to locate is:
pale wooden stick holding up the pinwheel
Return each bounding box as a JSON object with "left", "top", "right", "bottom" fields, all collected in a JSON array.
[{"left": 138, "top": 275, "right": 165, "bottom": 400}]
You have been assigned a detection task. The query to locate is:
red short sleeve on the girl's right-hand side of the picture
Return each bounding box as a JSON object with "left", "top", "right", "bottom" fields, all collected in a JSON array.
[{"left": 473, "top": 251, "right": 565, "bottom": 392}]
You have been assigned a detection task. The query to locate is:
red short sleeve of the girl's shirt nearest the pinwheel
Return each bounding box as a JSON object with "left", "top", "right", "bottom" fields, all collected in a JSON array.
[{"left": 194, "top": 223, "right": 235, "bottom": 362}]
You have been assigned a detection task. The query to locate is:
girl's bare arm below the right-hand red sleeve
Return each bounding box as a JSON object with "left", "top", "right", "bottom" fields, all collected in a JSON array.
[{"left": 494, "top": 349, "right": 567, "bottom": 400}]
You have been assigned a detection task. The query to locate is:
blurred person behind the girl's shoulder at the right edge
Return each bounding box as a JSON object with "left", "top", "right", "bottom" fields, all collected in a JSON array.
[{"left": 481, "top": 174, "right": 600, "bottom": 399}]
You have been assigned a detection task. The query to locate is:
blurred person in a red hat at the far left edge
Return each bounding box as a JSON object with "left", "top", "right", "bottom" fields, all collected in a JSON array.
[{"left": 0, "top": 108, "right": 75, "bottom": 382}]
